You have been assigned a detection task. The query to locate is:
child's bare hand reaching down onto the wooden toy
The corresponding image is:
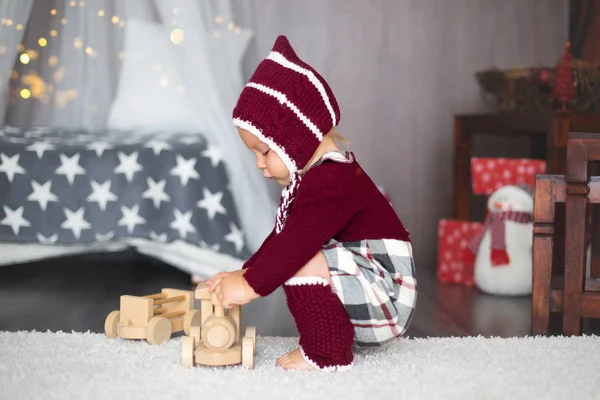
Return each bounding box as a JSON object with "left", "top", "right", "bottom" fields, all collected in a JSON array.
[{"left": 209, "top": 270, "right": 260, "bottom": 308}]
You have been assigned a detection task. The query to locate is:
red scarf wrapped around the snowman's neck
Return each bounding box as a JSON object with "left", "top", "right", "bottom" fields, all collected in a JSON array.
[{"left": 465, "top": 211, "right": 533, "bottom": 266}]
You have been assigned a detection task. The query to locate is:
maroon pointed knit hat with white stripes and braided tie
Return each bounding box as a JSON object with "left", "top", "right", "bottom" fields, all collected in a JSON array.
[{"left": 233, "top": 36, "right": 340, "bottom": 232}]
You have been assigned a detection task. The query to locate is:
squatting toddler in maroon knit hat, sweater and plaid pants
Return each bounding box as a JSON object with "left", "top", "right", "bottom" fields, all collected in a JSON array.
[{"left": 208, "top": 36, "right": 417, "bottom": 371}]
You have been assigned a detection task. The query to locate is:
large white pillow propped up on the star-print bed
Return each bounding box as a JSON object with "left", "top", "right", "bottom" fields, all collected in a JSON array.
[{"left": 107, "top": 20, "right": 202, "bottom": 132}]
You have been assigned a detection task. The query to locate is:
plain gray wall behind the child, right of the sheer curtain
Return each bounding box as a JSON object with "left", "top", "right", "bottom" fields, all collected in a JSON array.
[{"left": 246, "top": 0, "right": 567, "bottom": 269}]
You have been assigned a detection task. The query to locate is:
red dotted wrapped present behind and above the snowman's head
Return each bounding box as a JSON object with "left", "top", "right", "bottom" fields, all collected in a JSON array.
[{"left": 471, "top": 157, "right": 546, "bottom": 195}]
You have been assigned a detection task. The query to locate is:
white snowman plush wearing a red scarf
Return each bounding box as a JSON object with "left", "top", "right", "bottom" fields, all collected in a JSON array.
[{"left": 466, "top": 185, "right": 533, "bottom": 296}]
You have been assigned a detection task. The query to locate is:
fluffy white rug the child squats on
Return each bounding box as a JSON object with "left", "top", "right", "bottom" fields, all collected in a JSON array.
[{"left": 0, "top": 332, "right": 600, "bottom": 400}]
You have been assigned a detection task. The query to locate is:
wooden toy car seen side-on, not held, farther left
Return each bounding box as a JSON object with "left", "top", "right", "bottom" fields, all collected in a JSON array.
[{"left": 104, "top": 289, "right": 200, "bottom": 344}]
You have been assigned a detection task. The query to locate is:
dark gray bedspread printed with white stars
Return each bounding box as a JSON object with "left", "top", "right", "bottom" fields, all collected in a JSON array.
[{"left": 0, "top": 126, "right": 248, "bottom": 259}]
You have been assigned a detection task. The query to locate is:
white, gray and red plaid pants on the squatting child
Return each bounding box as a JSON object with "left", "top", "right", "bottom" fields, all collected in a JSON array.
[{"left": 322, "top": 239, "right": 417, "bottom": 347}]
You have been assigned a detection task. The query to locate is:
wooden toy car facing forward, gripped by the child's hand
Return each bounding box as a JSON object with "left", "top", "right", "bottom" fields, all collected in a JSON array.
[{"left": 181, "top": 282, "right": 256, "bottom": 369}]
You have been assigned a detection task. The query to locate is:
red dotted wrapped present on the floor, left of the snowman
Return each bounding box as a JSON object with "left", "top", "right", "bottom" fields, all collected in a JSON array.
[{"left": 437, "top": 219, "right": 483, "bottom": 286}]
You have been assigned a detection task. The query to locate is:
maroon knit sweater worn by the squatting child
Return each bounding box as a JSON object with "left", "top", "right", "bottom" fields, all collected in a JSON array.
[{"left": 243, "top": 160, "right": 410, "bottom": 296}]
